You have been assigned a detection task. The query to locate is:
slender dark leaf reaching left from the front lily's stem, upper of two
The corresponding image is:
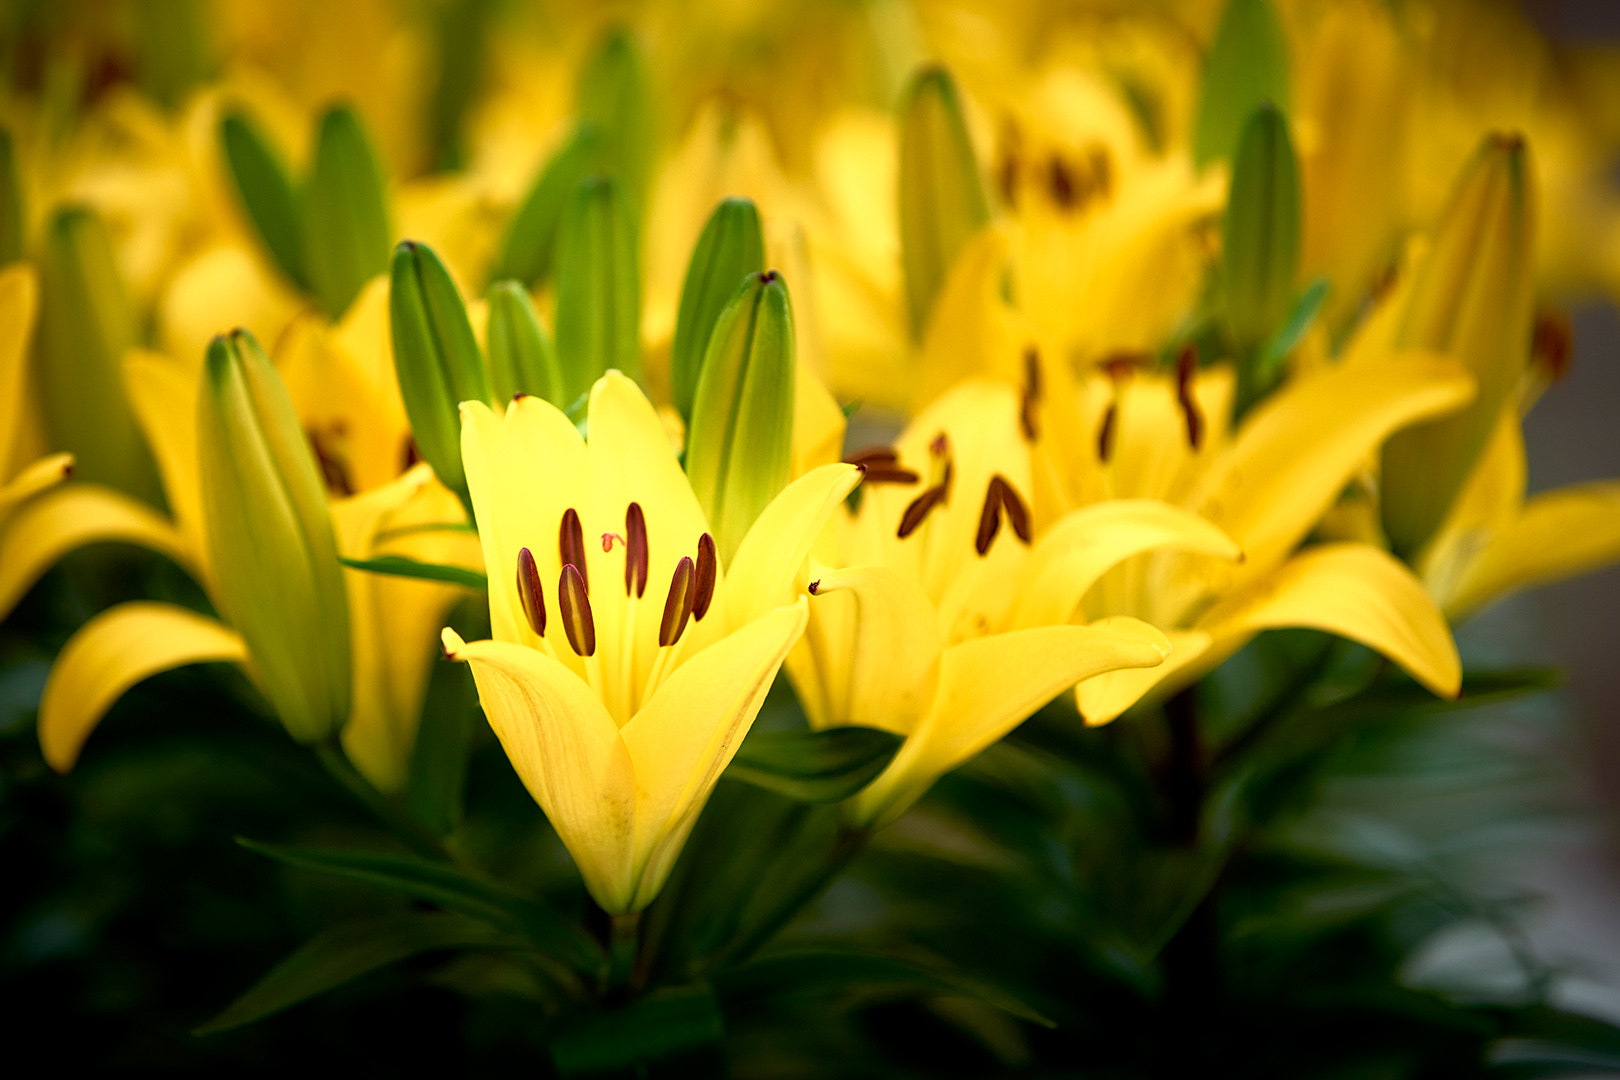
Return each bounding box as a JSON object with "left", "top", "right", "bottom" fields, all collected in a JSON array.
[{"left": 237, "top": 837, "right": 603, "bottom": 972}]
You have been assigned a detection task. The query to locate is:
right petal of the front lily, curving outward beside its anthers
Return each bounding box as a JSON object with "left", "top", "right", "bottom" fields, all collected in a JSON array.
[{"left": 726, "top": 463, "right": 860, "bottom": 627}]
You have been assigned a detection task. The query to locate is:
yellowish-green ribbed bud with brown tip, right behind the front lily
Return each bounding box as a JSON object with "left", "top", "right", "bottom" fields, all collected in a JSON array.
[{"left": 687, "top": 270, "right": 795, "bottom": 563}]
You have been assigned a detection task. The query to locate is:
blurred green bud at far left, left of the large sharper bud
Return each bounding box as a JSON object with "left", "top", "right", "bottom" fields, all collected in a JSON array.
[{"left": 39, "top": 207, "right": 162, "bottom": 505}]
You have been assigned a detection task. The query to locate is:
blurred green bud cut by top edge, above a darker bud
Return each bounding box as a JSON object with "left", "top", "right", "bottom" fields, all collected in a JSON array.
[{"left": 1192, "top": 0, "right": 1288, "bottom": 167}]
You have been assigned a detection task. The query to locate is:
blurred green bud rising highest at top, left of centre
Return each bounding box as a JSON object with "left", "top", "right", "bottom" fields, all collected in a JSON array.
[{"left": 573, "top": 28, "right": 658, "bottom": 210}]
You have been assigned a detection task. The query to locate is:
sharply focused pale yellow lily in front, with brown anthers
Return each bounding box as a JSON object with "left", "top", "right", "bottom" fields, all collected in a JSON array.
[{"left": 444, "top": 372, "right": 860, "bottom": 913}]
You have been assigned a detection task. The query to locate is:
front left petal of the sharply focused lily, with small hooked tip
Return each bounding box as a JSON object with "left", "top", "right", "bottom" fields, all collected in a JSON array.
[{"left": 444, "top": 630, "right": 635, "bottom": 912}]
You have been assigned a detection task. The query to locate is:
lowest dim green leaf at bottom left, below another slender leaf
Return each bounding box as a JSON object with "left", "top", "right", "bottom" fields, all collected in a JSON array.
[{"left": 193, "top": 912, "right": 522, "bottom": 1035}]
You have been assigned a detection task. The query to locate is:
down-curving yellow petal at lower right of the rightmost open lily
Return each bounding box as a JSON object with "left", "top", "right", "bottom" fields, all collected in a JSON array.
[{"left": 1199, "top": 544, "right": 1461, "bottom": 698}]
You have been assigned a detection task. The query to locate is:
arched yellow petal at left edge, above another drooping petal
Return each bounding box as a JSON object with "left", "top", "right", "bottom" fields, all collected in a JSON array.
[{"left": 0, "top": 484, "right": 196, "bottom": 614}]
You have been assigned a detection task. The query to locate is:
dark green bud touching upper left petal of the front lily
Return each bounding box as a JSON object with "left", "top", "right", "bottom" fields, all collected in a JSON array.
[{"left": 389, "top": 240, "right": 492, "bottom": 500}]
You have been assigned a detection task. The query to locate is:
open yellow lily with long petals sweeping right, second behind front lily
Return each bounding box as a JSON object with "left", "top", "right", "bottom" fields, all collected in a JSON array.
[{"left": 1032, "top": 335, "right": 1473, "bottom": 724}]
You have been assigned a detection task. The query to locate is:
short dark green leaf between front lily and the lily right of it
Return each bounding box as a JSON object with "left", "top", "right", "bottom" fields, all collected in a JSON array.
[{"left": 726, "top": 727, "right": 906, "bottom": 803}]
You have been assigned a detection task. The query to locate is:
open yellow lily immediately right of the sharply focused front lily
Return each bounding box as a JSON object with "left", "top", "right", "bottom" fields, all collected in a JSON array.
[{"left": 787, "top": 382, "right": 1179, "bottom": 827}]
